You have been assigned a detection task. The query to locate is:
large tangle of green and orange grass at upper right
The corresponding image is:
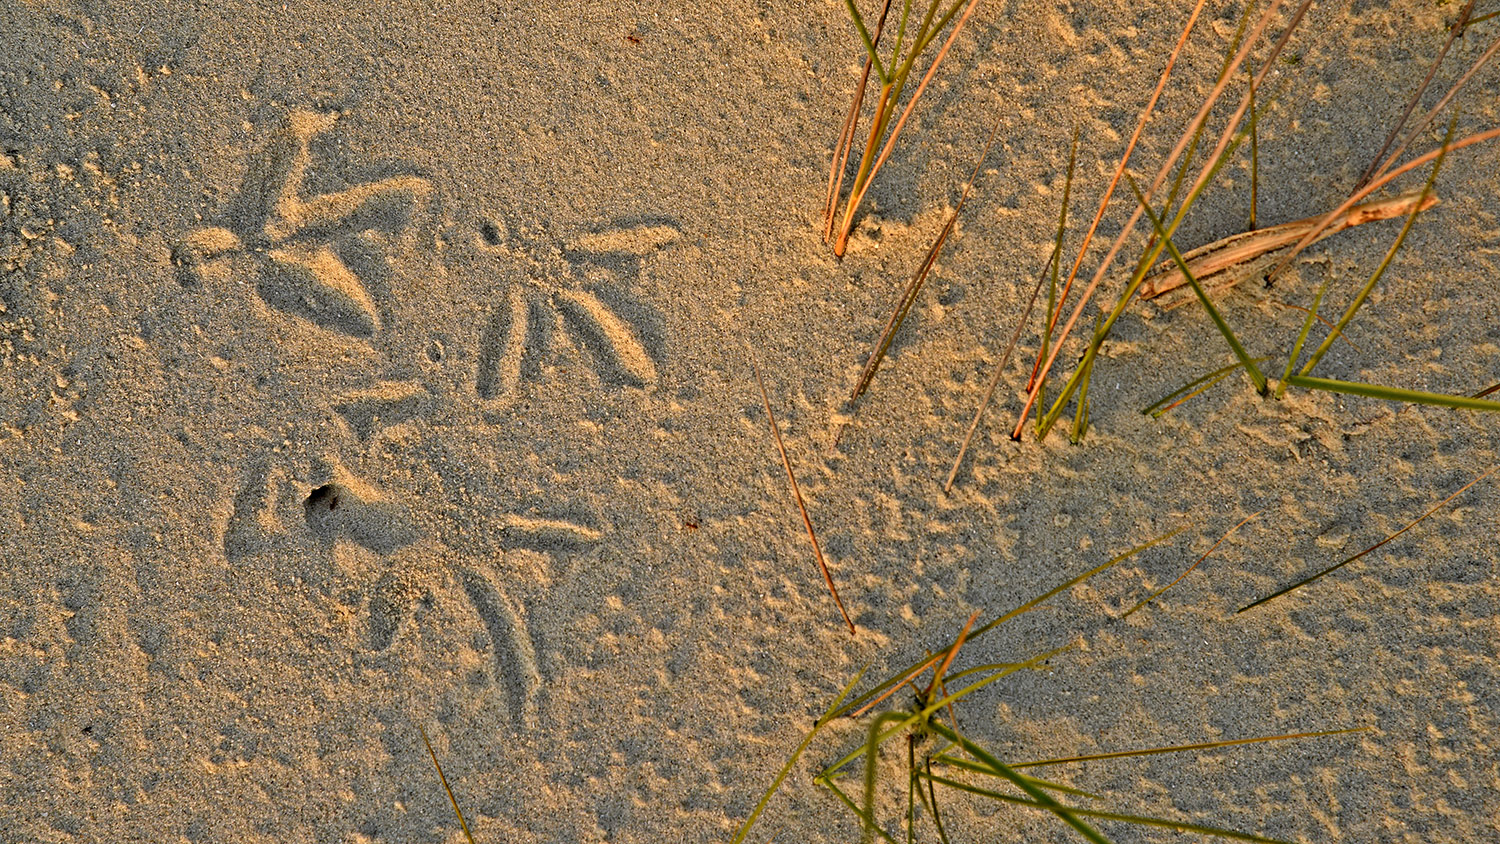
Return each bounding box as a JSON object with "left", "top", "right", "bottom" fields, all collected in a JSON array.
[{"left": 888, "top": 0, "right": 1500, "bottom": 461}]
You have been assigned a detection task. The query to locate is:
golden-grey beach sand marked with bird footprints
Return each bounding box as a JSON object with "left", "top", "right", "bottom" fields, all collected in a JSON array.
[{"left": 0, "top": 0, "right": 1500, "bottom": 844}]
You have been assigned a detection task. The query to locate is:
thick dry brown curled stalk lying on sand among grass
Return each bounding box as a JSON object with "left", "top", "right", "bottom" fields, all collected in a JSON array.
[{"left": 1139, "top": 190, "right": 1439, "bottom": 298}]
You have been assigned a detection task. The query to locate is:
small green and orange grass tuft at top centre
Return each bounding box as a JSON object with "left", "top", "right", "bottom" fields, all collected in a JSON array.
[{"left": 834, "top": 0, "right": 978, "bottom": 258}]
